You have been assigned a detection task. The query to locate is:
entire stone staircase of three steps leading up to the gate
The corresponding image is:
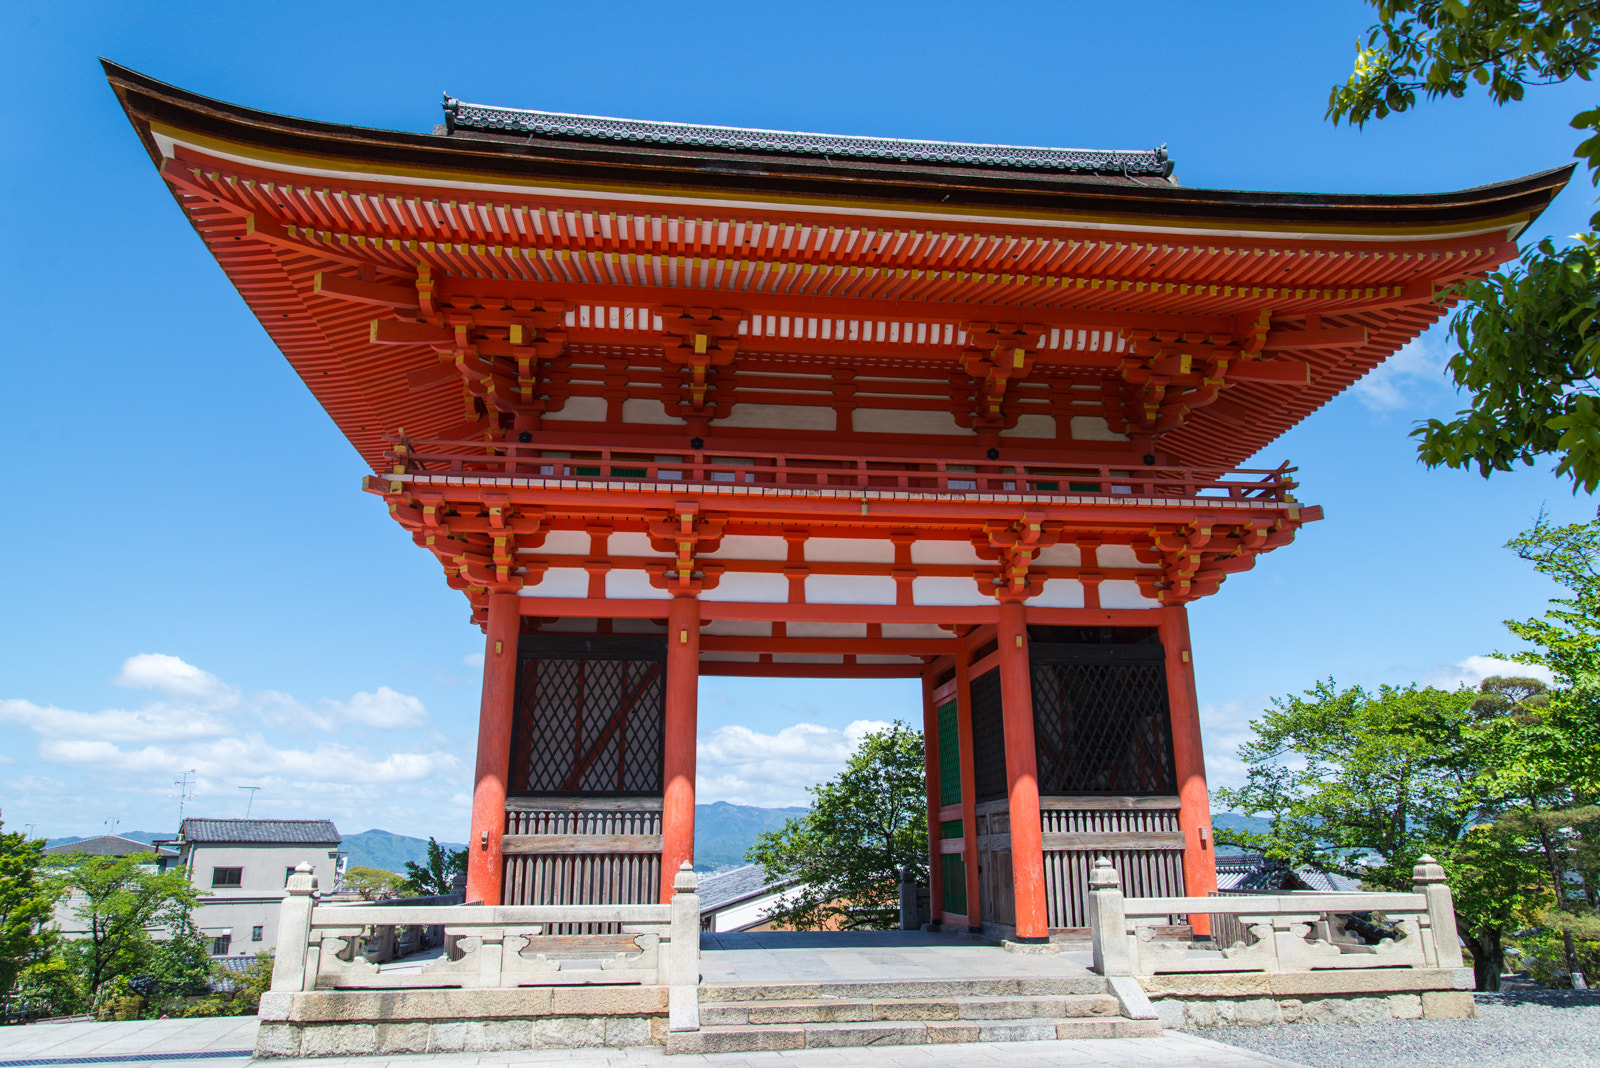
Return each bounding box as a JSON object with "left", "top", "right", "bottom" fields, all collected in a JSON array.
[{"left": 667, "top": 975, "right": 1162, "bottom": 1054}]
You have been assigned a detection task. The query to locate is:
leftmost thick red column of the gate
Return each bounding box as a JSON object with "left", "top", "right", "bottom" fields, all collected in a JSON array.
[{"left": 467, "top": 593, "right": 522, "bottom": 905}]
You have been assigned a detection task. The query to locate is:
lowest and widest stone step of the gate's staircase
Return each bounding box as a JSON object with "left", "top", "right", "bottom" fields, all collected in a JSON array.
[{"left": 667, "top": 1017, "right": 1162, "bottom": 1054}]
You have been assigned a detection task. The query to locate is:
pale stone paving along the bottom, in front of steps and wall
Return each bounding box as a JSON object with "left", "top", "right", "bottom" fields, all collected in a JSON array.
[{"left": 0, "top": 1017, "right": 1304, "bottom": 1068}]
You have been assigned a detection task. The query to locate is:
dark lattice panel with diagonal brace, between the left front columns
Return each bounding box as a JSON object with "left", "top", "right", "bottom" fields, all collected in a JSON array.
[{"left": 507, "top": 648, "right": 666, "bottom": 796}]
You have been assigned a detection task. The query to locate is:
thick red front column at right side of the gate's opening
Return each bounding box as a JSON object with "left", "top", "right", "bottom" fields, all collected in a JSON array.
[{"left": 998, "top": 601, "right": 1050, "bottom": 940}]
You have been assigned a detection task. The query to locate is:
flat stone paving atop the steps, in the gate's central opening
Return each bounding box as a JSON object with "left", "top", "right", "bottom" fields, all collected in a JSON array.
[{"left": 701, "top": 931, "right": 1091, "bottom": 983}]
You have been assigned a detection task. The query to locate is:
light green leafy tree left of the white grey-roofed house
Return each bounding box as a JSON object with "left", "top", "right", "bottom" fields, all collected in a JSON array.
[{"left": 51, "top": 854, "right": 211, "bottom": 1004}]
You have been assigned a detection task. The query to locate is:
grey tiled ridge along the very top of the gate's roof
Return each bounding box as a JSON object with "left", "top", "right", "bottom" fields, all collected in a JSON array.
[{"left": 445, "top": 96, "right": 1173, "bottom": 177}]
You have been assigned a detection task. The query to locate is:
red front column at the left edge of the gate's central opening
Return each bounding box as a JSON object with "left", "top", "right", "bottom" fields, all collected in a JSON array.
[{"left": 661, "top": 596, "right": 699, "bottom": 903}]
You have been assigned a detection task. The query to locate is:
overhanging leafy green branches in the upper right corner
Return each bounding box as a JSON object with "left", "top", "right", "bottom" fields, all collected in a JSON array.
[{"left": 1328, "top": 0, "right": 1600, "bottom": 492}]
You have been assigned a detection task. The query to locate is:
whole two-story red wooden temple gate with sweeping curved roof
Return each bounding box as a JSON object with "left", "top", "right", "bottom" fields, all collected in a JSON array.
[{"left": 107, "top": 64, "right": 1568, "bottom": 940}]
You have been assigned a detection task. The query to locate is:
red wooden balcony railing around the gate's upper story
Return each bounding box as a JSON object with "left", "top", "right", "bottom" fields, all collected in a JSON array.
[{"left": 384, "top": 436, "right": 1299, "bottom": 504}]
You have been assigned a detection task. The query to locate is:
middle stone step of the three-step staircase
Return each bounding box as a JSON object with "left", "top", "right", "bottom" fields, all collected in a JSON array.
[{"left": 701, "top": 994, "right": 1118, "bottom": 1026}]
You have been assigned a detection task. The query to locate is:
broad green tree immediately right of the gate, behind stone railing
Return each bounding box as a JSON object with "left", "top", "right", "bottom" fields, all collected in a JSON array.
[{"left": 1216, "top": 679, "right": 1544, "bottom": 990}]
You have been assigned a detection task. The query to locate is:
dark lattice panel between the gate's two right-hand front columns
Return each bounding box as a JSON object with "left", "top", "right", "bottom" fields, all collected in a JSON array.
[{"left": 1032, "top": 646, "right": 1178, "bottom": 795}]
